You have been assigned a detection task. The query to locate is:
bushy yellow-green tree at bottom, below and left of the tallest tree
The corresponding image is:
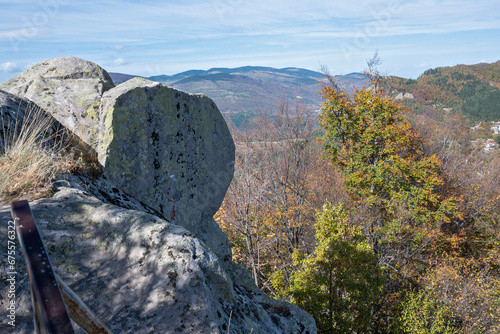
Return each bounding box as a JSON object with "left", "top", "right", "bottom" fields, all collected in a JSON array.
[{"left": 283, "top": 205, "right": 384, "bottom": 333}]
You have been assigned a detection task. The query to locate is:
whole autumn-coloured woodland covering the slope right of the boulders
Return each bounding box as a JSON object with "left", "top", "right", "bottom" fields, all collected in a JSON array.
[{"left": 216, "top": 64, "right": 500, "bottom": 333}]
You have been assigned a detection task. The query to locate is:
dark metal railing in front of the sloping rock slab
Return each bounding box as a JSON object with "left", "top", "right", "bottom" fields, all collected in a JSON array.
[{"left": 11, "top": 200, "right": 112, "bottom": 334}]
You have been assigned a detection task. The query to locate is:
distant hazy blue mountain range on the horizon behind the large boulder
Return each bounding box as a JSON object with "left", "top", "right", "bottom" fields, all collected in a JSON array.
[{"left": 109, "top": 66, "right": 367, "bottom": 126}]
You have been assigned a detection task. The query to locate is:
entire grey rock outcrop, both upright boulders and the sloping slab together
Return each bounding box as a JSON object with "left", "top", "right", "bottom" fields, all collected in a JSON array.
[{"left": 0, "top": 57, "right": 316, "bottom": 333}]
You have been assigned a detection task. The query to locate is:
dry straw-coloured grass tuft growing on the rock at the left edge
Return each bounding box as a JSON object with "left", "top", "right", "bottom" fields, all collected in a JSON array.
[{"left": 0, "top": 106, "right": 68, "bottom": 202}]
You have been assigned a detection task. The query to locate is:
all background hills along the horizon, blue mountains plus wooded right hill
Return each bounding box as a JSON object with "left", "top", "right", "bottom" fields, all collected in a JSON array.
[{"left": 109, "top": 61, "right": 500, "bottom": 127}]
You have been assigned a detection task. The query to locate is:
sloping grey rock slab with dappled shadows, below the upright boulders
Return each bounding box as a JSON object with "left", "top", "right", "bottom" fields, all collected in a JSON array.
[{"left": 0, "top": 182, "right": 316, "bottom": 334}]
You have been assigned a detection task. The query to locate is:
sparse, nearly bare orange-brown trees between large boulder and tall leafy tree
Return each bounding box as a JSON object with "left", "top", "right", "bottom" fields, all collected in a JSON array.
[{"left": 216, "top": 99, "right": 341, "bottom": 294}]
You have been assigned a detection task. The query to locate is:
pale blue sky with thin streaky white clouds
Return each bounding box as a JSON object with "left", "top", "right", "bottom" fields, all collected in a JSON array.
[{"left": 0, "top": 0, "right": 500, "bottom": 82}]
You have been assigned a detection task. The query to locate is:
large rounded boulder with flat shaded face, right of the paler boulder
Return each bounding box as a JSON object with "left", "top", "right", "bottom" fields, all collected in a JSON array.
[{"left": 97, "top": 78, "right": 234, "bottom": 260}]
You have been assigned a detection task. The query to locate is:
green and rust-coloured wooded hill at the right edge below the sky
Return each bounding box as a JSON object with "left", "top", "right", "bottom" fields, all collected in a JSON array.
[{"left": 383, "top": 61, "right": 500, "bottom": 122}]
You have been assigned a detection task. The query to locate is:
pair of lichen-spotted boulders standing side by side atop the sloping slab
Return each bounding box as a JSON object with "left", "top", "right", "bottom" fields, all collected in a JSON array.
[{"left": 0, "top": 57, "right": 234, "bottom": 259}]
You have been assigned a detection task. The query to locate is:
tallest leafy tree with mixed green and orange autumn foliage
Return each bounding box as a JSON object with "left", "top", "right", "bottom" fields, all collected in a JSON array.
[{"left": 320, "top": 67, "right": 456, "bottom": 276}]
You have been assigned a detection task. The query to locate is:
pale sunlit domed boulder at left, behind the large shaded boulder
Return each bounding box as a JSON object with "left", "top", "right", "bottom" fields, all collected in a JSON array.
[{"left": 0, "top": 57, "right": 114, "bottom": 146}]
